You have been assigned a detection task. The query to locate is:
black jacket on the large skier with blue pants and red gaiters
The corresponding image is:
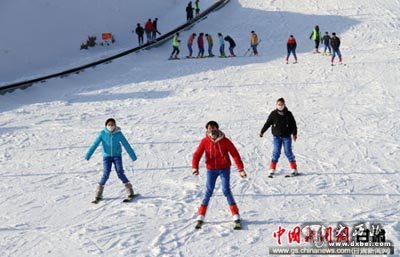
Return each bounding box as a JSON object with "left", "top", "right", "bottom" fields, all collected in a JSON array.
[{"left": 261, "top": 107, "right": 297, "bottom": 137}]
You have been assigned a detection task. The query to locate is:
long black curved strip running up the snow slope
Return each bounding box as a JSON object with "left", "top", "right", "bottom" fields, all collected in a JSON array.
[{"left": 0, "top": 0, "right": 230, "bottom": 94}]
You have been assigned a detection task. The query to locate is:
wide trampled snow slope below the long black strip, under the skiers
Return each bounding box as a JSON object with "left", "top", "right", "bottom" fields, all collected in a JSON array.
[{"left": 0, "top": 0, "right": 400, "bottom": 256}]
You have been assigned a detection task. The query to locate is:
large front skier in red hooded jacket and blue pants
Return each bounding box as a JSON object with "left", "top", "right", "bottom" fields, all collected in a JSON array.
[{"left": 192, "top": 121, "right": 247, "bottom": 226}]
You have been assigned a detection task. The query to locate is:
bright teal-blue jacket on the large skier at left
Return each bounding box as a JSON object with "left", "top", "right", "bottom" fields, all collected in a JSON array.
[{"left": 85, "top": 127, "right": 137, "bottom": 161}]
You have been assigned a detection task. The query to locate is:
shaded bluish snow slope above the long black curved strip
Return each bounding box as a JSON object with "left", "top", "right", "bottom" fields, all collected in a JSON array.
[{"left": 0, "top": 0, "right": 213, "bottom": 84}]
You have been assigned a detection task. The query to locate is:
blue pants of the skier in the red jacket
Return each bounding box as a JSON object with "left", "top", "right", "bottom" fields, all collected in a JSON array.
[{"left": 202, "top": 168, "right": 235, "bottom": 206}]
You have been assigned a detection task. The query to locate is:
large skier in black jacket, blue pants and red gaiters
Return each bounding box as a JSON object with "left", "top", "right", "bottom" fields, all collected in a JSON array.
[{"left": 260, "top": 98, "right": 298, "bottom": 176}]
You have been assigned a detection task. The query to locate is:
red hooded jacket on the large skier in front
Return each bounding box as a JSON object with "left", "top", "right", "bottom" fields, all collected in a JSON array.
[{"left": 192, "top": 132, "right": 244, "bottom": 171}]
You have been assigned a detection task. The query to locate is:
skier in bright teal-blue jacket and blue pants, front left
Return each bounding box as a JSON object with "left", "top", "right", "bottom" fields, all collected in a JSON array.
[{"left": 85, "top": 118, "right": 137, "bottom": 203}]
